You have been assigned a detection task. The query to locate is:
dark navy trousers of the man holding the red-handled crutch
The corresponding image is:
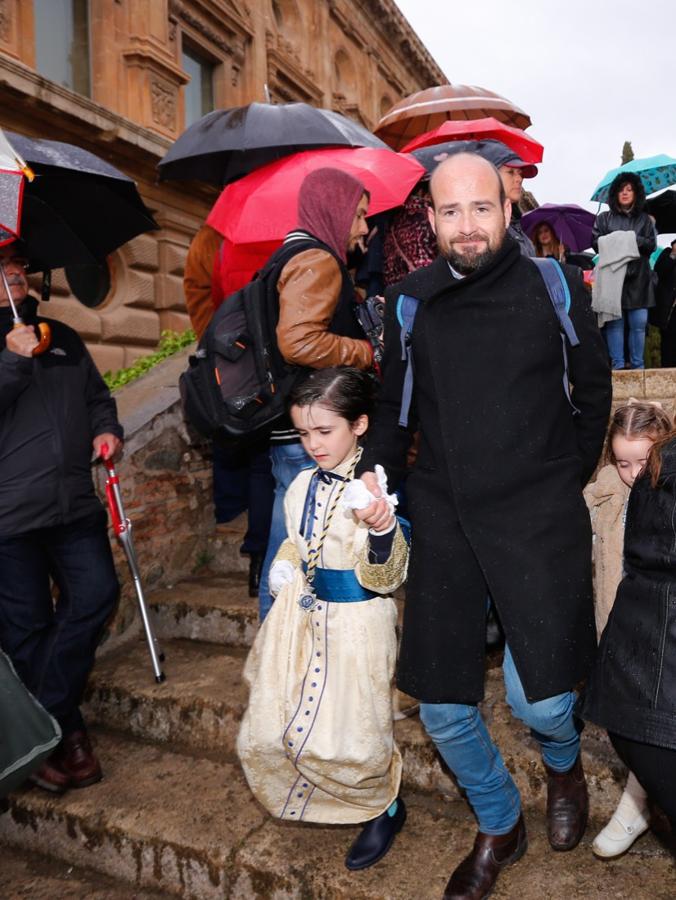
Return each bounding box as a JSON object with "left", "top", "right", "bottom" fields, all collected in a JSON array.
[{"left": 0, "top": 510, "right": 119, "bottom": 735}]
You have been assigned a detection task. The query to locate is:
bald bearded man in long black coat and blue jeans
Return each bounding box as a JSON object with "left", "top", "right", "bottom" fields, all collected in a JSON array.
[{"left": 360, "top": 153, "right": 611, "bottom": 898}]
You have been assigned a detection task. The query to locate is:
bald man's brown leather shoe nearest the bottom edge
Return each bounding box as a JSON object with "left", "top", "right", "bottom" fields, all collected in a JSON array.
[{"left": 444, "top": 815, "right": 528, "bottom": 900}]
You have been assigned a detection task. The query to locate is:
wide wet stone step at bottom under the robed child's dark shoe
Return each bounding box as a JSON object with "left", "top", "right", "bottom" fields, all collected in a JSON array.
[{"left": 0, "top": 730, "right": 676, "bottom": 900}]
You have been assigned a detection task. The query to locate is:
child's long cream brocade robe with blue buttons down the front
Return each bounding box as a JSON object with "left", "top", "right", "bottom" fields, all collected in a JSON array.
[{"left": 237, "top": 460, "right": 408, "bottom": 824}]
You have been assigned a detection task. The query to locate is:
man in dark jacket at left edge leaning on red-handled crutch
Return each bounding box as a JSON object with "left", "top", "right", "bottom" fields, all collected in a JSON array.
[{"left": 0, "top": 243, "right": 122, "bottom": 793}]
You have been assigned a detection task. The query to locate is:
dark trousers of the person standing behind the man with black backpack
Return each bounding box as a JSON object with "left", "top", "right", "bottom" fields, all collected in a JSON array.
[{"left": 214, "top": 441, "right": 275, "bottom": 553}]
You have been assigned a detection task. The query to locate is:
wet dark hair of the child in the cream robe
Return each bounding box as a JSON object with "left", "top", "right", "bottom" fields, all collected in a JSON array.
[{"left": 289, "top": 366, "right": 378, "bottom": 422}]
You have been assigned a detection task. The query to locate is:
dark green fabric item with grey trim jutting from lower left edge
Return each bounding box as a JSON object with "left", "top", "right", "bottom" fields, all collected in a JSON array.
[{"left": 0, "top": 650, "right": 61, "bottom": 797}]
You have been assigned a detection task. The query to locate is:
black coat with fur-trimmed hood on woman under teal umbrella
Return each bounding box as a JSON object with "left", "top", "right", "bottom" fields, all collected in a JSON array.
[{"left": 592, "top": 172, "right": 657, "bottom": 309}]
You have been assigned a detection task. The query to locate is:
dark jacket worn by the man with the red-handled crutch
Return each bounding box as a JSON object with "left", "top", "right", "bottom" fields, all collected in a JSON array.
[{"left": 0, "top": 297, "right": 123, "bottom": 537}]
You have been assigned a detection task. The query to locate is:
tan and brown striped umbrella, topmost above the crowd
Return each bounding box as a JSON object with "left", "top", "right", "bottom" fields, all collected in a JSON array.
[{"left": 375, "top": 84, "right": 531, "bottom": 150}]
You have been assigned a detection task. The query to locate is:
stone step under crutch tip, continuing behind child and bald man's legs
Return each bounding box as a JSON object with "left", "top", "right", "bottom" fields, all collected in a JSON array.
[{"left": 85, "top": 640, "right": 624, "bottom": 817}]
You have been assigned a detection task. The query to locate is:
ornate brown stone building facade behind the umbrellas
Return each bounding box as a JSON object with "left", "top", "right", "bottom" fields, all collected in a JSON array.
[{"left": 0, "top": 0, "right": 446, "bottom": 371}]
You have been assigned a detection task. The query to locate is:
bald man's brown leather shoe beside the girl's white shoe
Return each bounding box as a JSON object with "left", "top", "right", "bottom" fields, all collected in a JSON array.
[{"left": 545, "top": 754, "right": 589, "bottom": 850}]
